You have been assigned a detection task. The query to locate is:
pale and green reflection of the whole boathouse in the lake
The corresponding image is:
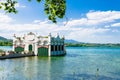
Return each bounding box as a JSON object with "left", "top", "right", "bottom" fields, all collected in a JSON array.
[{"left": 10, "top": 56, "right": 64, "bottom": 80}]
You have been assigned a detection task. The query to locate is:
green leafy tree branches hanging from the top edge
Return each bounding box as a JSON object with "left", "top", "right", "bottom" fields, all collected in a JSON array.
[{"left": 0, "top": 0, "right": 66, "bottom": 23}]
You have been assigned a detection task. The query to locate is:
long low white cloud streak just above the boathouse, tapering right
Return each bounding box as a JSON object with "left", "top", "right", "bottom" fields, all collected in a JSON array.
[{"left": 0, "top": 21, "right": 109, "bottom": 41}]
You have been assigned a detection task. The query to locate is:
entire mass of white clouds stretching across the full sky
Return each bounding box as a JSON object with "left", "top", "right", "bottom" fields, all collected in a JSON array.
[{"left": 0, "top": 11, "right": 120, "bottom": 42}]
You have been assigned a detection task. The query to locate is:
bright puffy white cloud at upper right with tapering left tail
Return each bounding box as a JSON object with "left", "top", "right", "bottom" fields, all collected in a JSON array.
[{"left": 68, "top": 11, "right": 120, "bottom": 26}]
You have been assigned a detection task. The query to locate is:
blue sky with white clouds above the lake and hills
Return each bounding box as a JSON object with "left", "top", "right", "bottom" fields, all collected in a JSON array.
[{"left": 0, "top": 0, "right": 120, "bottom": 43}]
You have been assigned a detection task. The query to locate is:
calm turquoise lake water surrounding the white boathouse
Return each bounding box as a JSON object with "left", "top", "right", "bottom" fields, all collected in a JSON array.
[{"left": 0, "top": 47, "right": 120, "bottom": 80}]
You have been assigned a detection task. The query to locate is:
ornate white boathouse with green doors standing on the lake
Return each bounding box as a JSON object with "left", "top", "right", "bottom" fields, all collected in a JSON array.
[{"left": 13, "top": 32, "right": 66, "bottom": 56}]
